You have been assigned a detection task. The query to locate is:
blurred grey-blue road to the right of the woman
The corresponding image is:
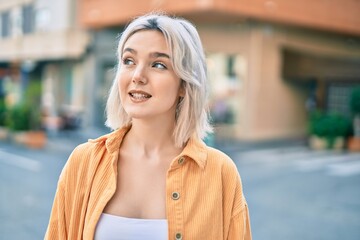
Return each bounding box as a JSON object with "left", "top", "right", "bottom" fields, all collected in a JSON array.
[{"left": 232, "top": 146, "right": 360, "bottom": 240}]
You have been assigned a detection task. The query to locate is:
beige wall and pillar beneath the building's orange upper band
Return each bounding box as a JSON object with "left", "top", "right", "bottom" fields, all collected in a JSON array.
[{"left": 198, "top": 23, "right": 360, "bottom": 140}]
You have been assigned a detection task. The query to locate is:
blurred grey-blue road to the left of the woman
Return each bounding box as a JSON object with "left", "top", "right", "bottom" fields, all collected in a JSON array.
[{"left": 0, "top": 143, "right": 68, "bottom": 240}]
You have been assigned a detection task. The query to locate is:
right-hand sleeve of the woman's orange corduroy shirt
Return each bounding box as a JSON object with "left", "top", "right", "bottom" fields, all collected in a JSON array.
[{"left": 227, "top": 203, "right": 252, "bottom": 240}]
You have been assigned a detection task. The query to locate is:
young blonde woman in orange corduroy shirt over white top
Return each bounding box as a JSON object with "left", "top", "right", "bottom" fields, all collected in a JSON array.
[{"left": 45, "top": 14, "right": 251, "bottom": 240}]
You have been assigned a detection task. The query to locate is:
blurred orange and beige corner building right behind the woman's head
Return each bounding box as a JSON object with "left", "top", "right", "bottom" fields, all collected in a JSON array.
[{"left": 79, "top": 0, "right": 360, "bottom": 140}]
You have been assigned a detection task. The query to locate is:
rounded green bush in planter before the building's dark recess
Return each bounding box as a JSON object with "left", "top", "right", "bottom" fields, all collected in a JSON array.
[{"left": 309, "top": 111, "right": 351, "bottom": 148}]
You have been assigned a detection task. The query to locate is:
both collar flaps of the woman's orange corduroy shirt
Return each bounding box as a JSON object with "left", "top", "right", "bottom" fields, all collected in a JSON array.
[{"left": 89, "top": 126, "right": 207, "bottom": 169}]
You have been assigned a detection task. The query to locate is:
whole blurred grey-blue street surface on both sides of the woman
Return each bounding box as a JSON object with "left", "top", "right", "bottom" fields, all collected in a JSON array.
[{"left": 0, "top": 137, "right": 360, "bottom": 240}]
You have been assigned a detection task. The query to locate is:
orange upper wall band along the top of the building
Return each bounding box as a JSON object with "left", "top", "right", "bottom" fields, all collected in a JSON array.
[{"left": 79, "top": 0, "right": 360, "bottom": 35}]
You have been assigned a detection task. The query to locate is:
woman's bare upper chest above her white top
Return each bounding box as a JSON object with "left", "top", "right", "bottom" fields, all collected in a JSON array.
[{"left": 105, "top": 155, "right": 167, "bottom": 218}]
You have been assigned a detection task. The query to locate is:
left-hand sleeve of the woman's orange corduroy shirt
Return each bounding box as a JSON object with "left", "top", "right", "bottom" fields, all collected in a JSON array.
[{"left": 44, "top": 179, "right": 67, "bottom": 240}]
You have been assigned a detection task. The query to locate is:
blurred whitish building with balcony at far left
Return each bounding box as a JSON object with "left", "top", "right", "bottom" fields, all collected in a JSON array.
[{"left": 0, "top": 0, "right": 90, "bottom": 129}]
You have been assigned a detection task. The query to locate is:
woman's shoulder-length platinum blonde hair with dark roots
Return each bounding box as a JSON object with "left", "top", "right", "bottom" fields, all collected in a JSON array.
[{"left": 105, "top": 14, "right": 212, "bottom": 147}]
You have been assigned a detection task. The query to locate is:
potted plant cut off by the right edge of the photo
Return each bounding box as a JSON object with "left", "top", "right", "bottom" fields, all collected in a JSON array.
[{"left": 348, "top": 87, "right": 360, "bottom": 151}]
